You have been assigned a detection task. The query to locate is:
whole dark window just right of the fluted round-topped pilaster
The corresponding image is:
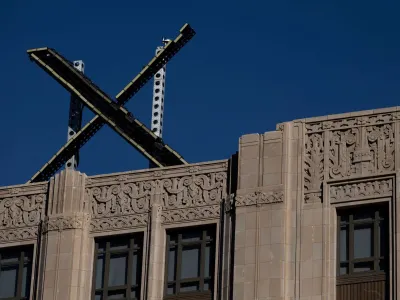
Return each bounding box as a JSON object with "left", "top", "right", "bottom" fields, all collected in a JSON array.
[{"left": 92, "top": 234, "right": 143, "bottom": 300}]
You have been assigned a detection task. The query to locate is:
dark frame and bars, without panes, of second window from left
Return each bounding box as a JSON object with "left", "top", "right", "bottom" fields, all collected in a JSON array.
[{"left": 91, "top": 232, "right": 144, "bottom": 300}]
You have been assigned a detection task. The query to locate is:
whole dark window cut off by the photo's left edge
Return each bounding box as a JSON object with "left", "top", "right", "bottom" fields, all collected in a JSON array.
[{"left": 0, "top": 247, "right": 33, "bottom": 300}]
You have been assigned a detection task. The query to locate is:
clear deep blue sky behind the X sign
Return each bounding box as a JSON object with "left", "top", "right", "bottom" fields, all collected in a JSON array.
[{"left": 0, "top": 0, "right": 400, "bottom": 186}]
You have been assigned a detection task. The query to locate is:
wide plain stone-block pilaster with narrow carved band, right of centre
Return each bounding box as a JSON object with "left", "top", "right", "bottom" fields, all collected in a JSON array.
[{"left": 233, "top": 128, "right": 289, "bottom": 299}]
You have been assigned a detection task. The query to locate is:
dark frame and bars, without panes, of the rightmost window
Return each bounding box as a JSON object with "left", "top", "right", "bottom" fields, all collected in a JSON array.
[{"left": 336, "top": 202, "right": 390, "bottom": 281}]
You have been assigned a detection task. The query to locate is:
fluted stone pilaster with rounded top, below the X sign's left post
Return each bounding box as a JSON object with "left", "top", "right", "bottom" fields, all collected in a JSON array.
[{"left": 39, "top": 170, "right": 93, "bottom": 300}]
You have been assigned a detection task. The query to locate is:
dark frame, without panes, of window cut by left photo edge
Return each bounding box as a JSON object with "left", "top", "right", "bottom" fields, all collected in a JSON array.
[{"left": 0, "top": 244, "right": 34, "bottom": 300}]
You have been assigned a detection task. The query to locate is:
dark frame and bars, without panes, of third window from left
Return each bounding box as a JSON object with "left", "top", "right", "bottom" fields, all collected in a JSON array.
[{"left": 163, "top": 223, "right": 217, "bottom": 299}]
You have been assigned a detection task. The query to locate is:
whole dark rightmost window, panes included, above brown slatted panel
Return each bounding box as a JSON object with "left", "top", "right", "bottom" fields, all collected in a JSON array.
[{"left": 338, "top": 205, "right": 389, "bottom": 276}]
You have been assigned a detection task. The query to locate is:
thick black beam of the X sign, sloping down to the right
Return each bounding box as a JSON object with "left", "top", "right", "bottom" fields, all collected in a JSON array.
[{"left": 30, "top": 48, "right": 186, "bottom": 173}]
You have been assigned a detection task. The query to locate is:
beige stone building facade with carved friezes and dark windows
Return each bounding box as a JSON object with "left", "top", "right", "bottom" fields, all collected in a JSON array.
[{"left": 0, "top": 107, "right": 400, "bottom": 300}]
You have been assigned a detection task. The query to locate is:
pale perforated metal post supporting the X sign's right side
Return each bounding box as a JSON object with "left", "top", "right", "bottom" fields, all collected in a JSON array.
[{"left": 151, "top": 39, "right": 170, "bottom": 139}]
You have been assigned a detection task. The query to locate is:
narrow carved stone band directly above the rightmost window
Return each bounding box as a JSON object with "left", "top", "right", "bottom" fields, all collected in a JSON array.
[{"left": 329, "top": 178, "right": 393, "bottom": 203}]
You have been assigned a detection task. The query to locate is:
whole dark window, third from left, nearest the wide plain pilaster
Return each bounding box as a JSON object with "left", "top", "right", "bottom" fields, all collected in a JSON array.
[{"left": 165, "top": 226, "right": 215, "bottom": 299}]
